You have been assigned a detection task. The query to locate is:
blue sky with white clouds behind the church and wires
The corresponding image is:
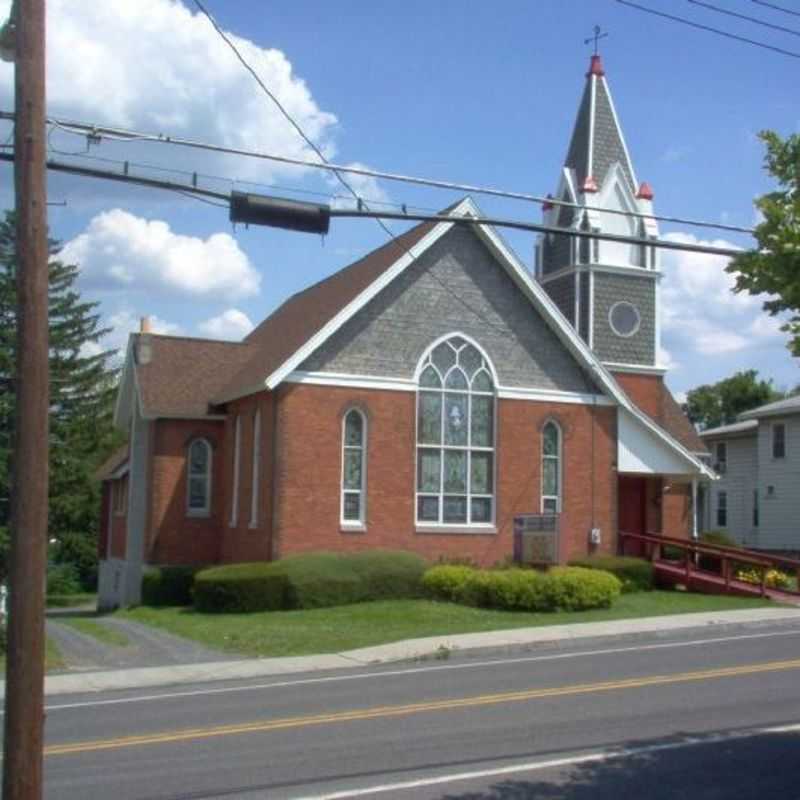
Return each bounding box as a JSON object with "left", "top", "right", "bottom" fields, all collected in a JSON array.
[{"left": 0, "top": 0, "right": 800, "bottom": 398}]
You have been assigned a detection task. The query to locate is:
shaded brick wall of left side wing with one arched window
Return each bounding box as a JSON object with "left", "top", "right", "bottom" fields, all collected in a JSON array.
[{"left": 145, "top": 419, "right": 226, "bottom": 564}]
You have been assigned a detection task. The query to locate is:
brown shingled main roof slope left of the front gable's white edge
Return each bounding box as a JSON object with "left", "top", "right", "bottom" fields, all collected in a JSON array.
[{"left": 212, "top": 216, "right": 438, "bottom": 403}]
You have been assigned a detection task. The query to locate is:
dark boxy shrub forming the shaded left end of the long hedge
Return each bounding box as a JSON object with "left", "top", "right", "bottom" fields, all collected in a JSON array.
[{"left": 192, "top": 562, "right": 289, "bottom": 613}]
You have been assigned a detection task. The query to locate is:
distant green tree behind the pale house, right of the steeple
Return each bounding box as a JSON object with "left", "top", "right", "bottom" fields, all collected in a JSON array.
[{"left": 684, "top": 369, "right": 783, "bottom": 429}]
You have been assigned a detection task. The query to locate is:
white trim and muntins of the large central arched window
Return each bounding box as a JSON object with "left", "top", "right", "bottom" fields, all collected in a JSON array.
[{"left": 412, "top": 331, "right": 498, "bottom": 534}]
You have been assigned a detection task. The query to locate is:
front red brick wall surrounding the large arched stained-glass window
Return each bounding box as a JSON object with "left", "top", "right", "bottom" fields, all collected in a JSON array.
[{"left": 272, "top": 384, "right": 616, "bottom": 565}]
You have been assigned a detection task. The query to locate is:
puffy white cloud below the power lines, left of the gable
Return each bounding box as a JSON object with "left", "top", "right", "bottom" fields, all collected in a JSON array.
[{"left": 58, "top": 208, "right": 261, "bottom": 298}]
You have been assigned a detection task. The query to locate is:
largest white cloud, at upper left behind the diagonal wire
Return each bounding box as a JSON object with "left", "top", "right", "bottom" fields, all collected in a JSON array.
[{"left": 0, "top": 0, "right": 337, "bottom": 178}]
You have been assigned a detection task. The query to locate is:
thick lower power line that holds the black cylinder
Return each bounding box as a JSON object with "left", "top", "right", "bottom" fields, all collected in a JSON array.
[{"left": 0, "top": 153, "right": 743, "bottom": 258}]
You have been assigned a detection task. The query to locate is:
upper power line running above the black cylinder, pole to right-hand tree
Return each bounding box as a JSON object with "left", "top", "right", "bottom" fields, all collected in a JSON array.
[{"left": 0, "top": 112, "right": 755, "bottom": 234}]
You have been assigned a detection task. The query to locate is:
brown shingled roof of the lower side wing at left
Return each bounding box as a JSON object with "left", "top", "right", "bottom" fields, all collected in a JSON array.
[{"left": 133, "top": 334, "right": 256, "bottom": 417}]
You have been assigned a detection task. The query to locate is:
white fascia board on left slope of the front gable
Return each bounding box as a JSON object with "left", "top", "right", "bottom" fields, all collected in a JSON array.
[{"left": 265, "top": 198, "right": 477, "bottom": 389}]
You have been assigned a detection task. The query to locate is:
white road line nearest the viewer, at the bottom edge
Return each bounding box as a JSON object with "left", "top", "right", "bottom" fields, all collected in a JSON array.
[{"left": 296, "top": 723, "right": 800, "bottom": 800}]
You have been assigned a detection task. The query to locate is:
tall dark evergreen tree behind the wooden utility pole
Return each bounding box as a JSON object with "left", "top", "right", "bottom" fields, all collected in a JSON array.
[{"left": 0, "top": 213, "right": 120, "bottom": 588}]
